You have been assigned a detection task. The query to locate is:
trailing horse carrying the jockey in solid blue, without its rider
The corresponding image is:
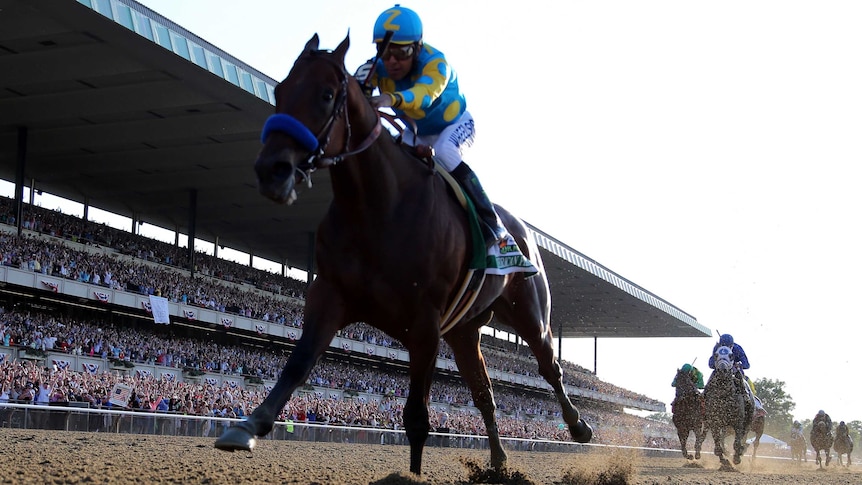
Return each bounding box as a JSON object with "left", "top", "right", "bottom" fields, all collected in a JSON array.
[{"left": 703, "top": 360, "right": 754, "bottom": 466}]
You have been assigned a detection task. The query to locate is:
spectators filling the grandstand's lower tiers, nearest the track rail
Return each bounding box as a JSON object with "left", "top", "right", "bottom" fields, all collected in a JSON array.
[{"left": 0, "top": 311, "right": 667, "bottom": 444}]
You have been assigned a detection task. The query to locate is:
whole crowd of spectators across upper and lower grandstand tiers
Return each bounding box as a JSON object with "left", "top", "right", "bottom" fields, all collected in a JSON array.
[{"left": 0, "top": 199, "right": 676, "bottom": 446}]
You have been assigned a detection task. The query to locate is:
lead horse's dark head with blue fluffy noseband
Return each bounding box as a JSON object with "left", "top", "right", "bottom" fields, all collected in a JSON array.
[{"left": 254, "top": 34, "right": 380, "bottom": 204}]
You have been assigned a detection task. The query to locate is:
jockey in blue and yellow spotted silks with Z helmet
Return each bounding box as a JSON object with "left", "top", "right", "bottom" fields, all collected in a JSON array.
[{"left": 354, "top": 4, "right": 508, "bottom": 246}]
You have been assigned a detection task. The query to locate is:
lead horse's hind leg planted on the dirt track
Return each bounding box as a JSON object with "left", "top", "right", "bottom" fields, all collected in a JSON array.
[{"left": 443, "top": 325, "right": 507, "bottom": 470}]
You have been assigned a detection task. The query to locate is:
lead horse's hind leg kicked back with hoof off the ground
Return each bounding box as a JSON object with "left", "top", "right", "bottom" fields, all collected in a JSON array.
[{"left": 492, "top": 276, "right": 593, "bottom": 443}]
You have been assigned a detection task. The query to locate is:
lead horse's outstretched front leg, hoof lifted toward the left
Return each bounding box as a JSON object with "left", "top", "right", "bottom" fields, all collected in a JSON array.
[{"left": 215, "top": 279, "right": 346, "bottom": 451}]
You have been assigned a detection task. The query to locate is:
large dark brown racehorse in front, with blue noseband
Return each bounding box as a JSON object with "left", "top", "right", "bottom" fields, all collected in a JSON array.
[{"left": 215, "top": 34, "right": 592, "bottom": 474}]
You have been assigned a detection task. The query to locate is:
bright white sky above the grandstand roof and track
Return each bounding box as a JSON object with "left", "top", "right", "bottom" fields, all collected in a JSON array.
[{"left": 6, "top": 0, "right": 862, "bottom": 421}]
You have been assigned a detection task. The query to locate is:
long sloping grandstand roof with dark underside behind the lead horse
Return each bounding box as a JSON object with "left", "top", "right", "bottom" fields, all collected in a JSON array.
[{"left": 0, "top": 0, "right": 711, "bottom": 338}]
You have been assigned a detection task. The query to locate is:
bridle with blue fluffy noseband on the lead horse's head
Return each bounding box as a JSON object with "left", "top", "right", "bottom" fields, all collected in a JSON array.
[{"left": 260, "top": 50, "right": 383, "bottom": 187}]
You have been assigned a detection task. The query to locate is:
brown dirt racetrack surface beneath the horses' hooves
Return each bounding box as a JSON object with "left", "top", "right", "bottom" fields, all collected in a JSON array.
[{"left": 0, "top": 429, "right": 862, "bottom": 485}]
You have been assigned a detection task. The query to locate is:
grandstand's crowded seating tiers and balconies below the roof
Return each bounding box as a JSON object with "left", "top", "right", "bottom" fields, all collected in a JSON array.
[{"left": 0, "top": 199, "right": 668, "bottom": 442}]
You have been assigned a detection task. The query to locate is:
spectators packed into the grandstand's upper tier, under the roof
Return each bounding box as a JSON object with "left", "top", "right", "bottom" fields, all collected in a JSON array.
[{"left": 0, "top": 198, "right": 659, "bottom": 404}]
